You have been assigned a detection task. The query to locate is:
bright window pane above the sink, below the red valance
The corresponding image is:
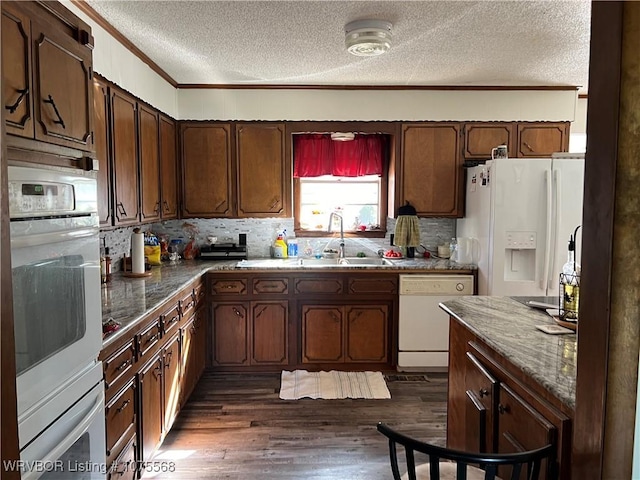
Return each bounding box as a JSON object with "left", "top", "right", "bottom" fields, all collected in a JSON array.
[{"left": 296, "top": 175, "right": 381, "bottom": 232}]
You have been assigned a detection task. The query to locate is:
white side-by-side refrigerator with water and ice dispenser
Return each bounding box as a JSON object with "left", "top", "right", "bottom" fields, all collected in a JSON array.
[{"left": 456, "top": 154, "right": 584, "bottom": 297}]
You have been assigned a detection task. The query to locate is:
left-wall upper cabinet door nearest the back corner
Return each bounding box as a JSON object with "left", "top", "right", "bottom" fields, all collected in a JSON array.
[{"left": 160, "top": 115, "right": 178, "bottom": 220}]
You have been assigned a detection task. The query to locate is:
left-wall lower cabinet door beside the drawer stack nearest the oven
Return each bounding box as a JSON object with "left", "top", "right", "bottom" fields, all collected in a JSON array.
[{"left": 138, "top": 352, "right": 164, "bottom": 461}]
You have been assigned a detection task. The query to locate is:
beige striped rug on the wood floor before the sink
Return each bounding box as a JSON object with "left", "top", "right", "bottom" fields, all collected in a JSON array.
[{"left": 280, "top": 370, "right": 391, "bottom": 400}]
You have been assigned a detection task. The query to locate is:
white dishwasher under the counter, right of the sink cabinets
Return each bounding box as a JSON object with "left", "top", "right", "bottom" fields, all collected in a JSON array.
[{"left": 398, "top": 274, "right": 473, "bottom": 371}]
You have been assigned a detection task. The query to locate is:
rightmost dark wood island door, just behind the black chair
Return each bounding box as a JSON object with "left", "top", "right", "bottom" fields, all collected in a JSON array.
[{"left": 497, "top": 383, "right": 557, "bottom": 479}]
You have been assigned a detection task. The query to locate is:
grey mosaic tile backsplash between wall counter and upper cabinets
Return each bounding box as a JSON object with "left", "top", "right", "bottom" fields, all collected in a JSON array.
[{"left": 100, "top": 218, "right": 455, "bottom": 271}]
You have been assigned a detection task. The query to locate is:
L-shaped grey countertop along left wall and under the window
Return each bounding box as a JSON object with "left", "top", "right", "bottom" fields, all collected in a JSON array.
[{"left": 102, "top": 258, "right": 477, "bottom": 347}]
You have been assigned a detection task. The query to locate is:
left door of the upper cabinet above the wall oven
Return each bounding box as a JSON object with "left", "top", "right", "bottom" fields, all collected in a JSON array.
[{"left": 2, "top": 2, "right": 34, "bottom": 138}]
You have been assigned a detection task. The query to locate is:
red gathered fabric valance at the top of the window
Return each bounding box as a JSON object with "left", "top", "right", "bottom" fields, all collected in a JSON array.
[{"left": 293, "top": 133, "right": 386, "bottom": 177}]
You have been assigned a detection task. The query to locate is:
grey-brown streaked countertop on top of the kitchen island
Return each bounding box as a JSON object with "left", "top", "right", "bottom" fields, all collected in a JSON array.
[{"left": 440, "top": 296, "right": 577, "bottom": 409}]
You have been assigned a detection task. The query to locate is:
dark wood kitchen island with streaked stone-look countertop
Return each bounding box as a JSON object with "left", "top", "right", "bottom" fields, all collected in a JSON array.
[{"left": 441, "top": 296, "right": 577, "bottom": 478}]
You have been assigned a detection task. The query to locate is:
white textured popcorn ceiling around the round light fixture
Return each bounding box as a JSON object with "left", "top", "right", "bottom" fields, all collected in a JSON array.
[{"left": 86, "top": 0, "right": 591, "bottom": 92}]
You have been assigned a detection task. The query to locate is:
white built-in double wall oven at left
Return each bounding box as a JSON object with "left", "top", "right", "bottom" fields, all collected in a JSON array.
[{"left": 8, "top": 166, "right": 105, "bottom": 480}]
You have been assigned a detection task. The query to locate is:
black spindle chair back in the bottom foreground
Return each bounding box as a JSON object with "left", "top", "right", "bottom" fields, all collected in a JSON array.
[{"left": 378, "top": 423, "right": 555, "bottom": 480}]
